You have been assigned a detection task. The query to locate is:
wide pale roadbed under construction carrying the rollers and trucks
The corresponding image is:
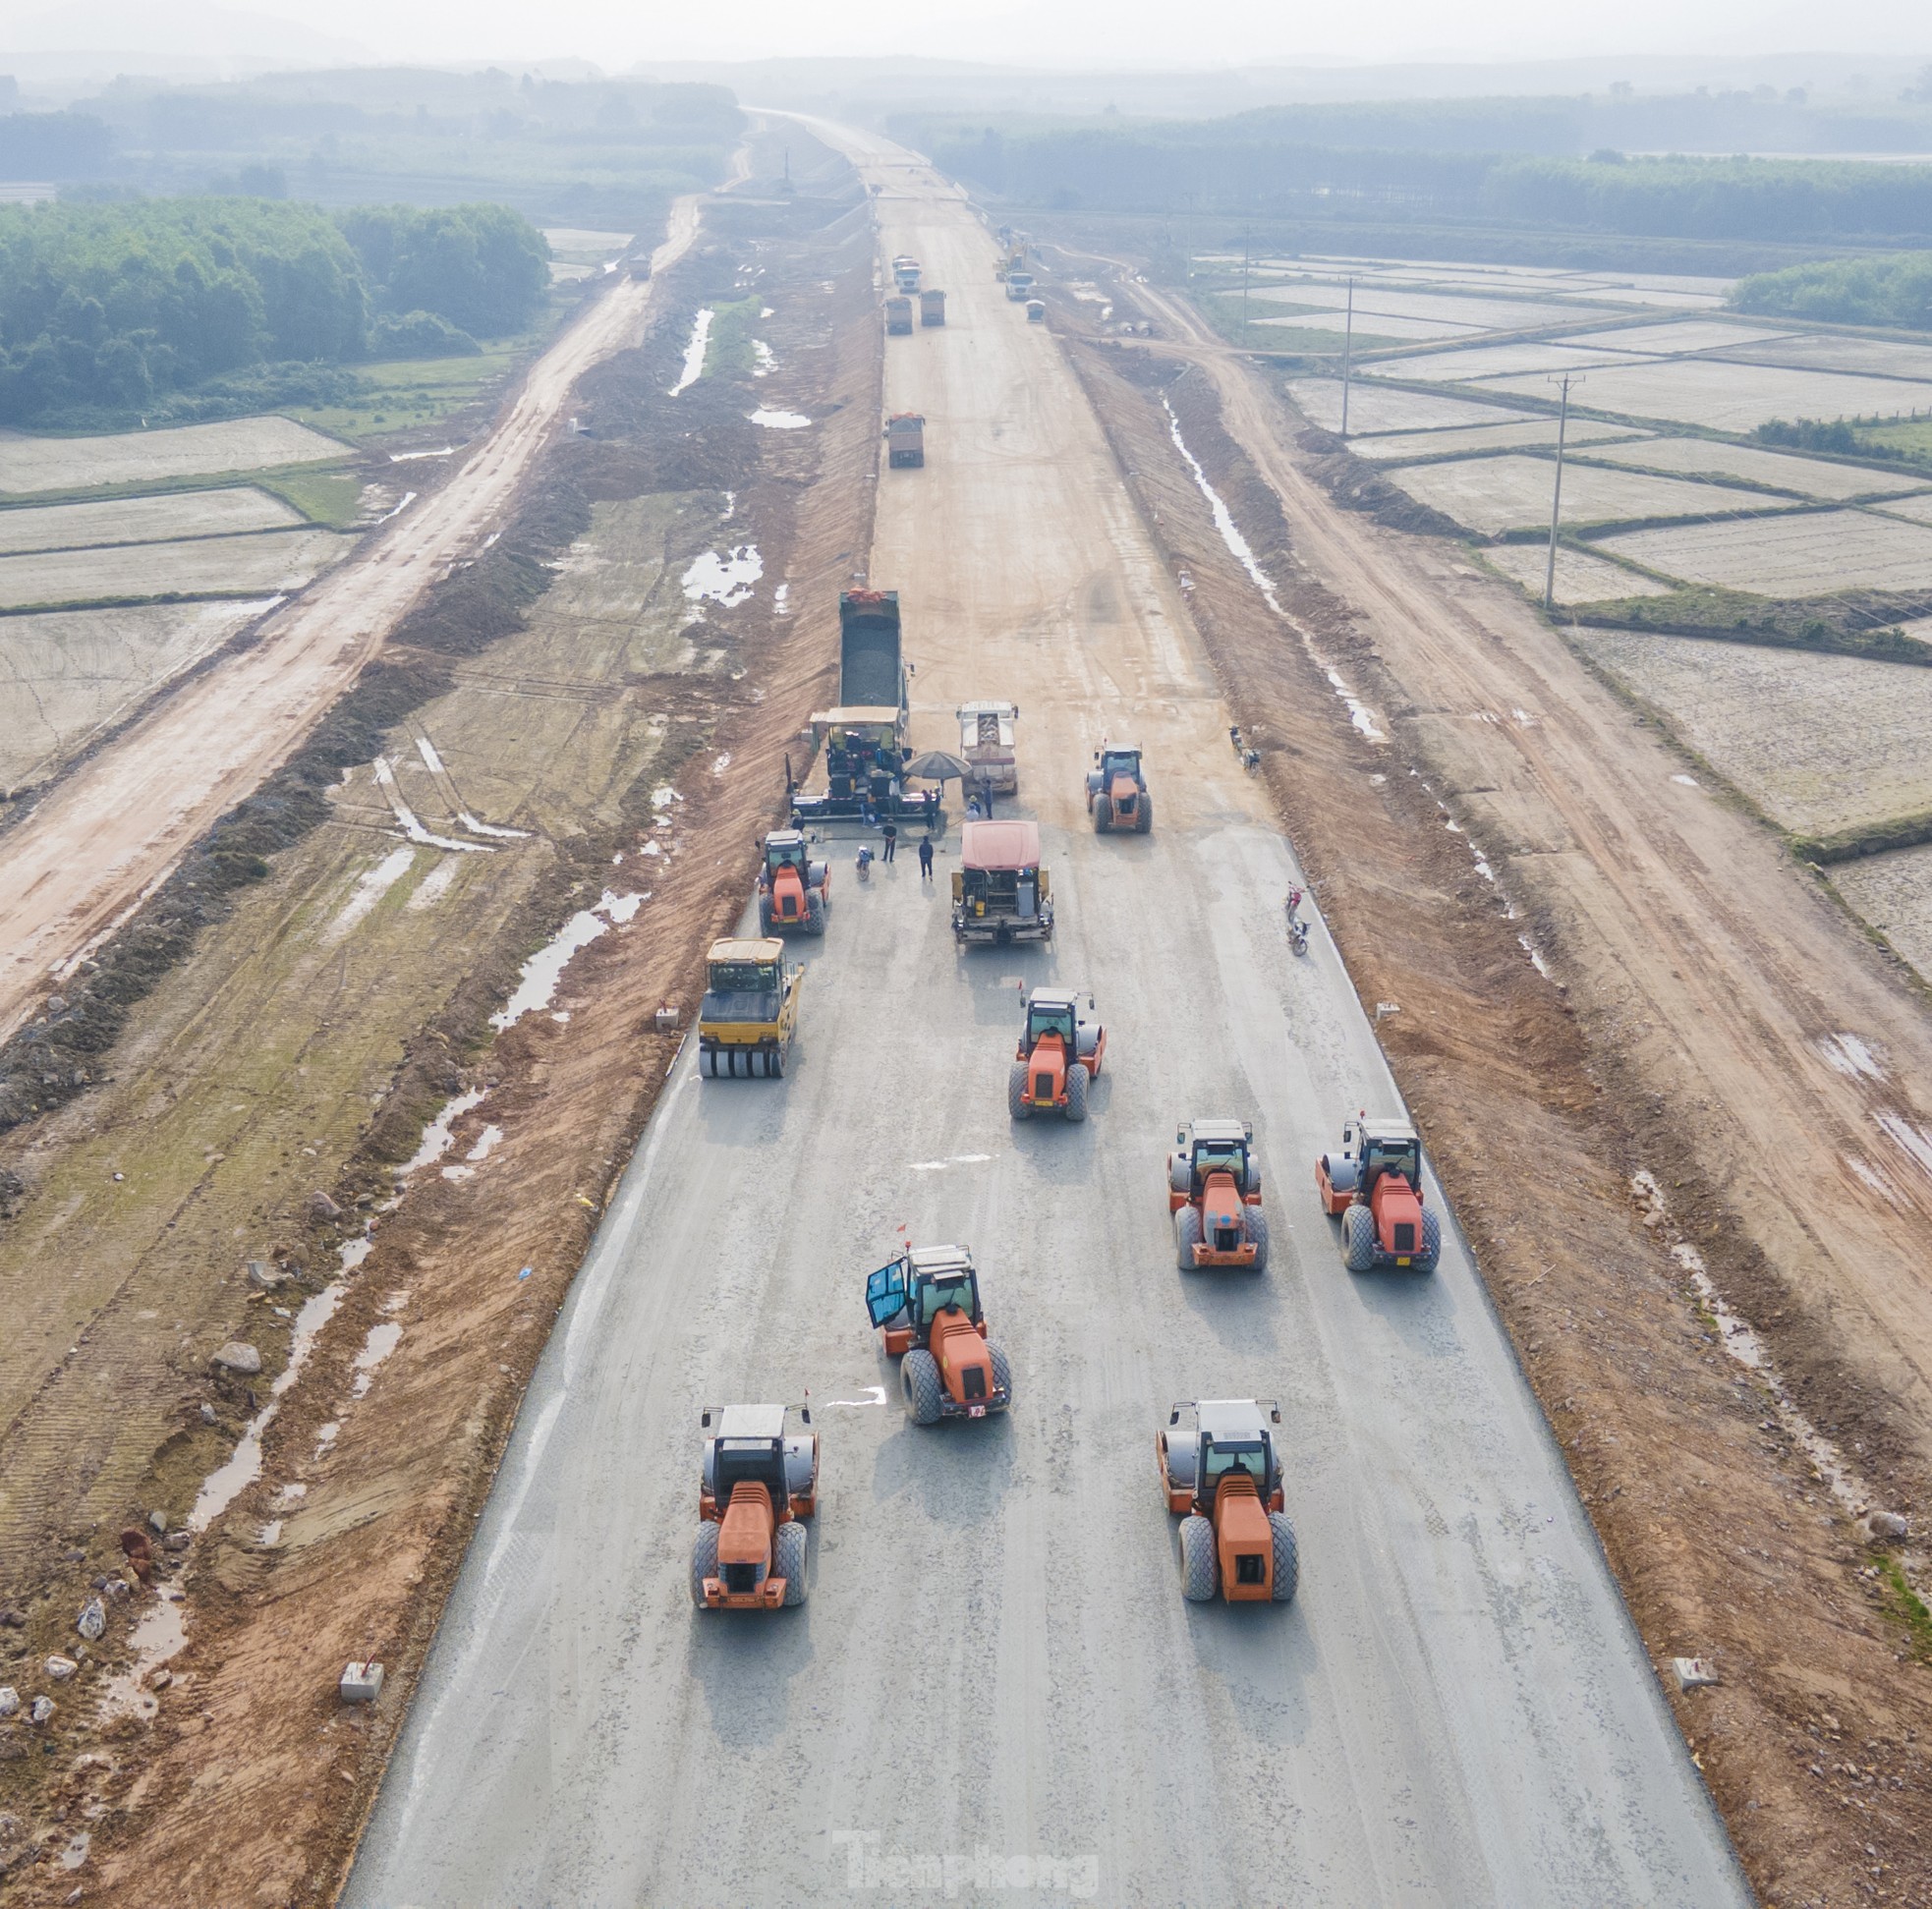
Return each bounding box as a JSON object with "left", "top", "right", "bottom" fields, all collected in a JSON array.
[{"left": 348, "top": 126, "right": 1748, "bottom": 1909}]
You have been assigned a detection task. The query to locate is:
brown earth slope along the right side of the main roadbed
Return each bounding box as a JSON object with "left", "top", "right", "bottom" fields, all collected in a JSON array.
[{"left": 1070, "top": 344, "right": 1932, "bottom": 1905}]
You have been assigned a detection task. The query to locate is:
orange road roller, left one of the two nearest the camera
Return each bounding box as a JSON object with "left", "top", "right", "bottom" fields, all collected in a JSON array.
[{"left": 692, "top": 1405, "right": 820, "bottom": 1611}]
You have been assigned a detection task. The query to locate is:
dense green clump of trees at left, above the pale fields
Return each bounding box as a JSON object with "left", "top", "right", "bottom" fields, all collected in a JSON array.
[{"left": 0, "top": 199, "right": 548, "bottom": 423}]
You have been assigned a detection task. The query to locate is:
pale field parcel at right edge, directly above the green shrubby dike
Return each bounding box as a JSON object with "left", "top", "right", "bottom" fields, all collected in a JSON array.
[{"left": 1600, "top": 510, "right": 1932, "bottom": 597}]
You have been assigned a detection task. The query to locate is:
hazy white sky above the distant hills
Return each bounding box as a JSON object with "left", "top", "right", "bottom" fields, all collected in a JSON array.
[{"left": 11, "top": 0, "right": 1932, "bottom": 70}]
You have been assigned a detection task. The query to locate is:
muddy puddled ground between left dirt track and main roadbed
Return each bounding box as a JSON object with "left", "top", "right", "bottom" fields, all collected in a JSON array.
[{"left": 0, "top": 132, "right": 881, "bottom": 1905}]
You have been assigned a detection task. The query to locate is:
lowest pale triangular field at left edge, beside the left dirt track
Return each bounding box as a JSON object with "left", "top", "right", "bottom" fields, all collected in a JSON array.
[{"left": 0, "top": 597, "right": 274, "bottom": 798}]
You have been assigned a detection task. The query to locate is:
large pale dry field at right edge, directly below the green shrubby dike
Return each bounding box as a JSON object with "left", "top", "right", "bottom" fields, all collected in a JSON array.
[{"left": 1572, "top": 630, "right": 1932, "bottom": 835}]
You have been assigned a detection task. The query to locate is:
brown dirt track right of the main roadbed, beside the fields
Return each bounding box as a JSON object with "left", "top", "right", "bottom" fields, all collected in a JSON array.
[{"left": 1134, "top": 286, "right": 1932, "bottom": 1503}]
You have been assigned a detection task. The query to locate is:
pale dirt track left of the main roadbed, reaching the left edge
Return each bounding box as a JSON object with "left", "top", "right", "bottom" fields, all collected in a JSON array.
[{"left": 0, "top": 182, "right": 726, "bottom": 1039}]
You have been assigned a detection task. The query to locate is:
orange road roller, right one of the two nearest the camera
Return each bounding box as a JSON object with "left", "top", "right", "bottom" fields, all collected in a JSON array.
[{"left": 1154, "top": 1399, "right": 1302, "bottom": 1603}]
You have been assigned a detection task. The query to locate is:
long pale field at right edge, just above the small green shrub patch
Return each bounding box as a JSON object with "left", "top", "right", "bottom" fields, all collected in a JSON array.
[{"left": 1486, "top": 358, "right": 1932, "bottom": 431}]
